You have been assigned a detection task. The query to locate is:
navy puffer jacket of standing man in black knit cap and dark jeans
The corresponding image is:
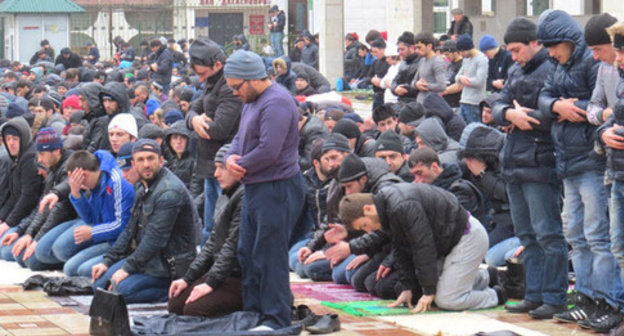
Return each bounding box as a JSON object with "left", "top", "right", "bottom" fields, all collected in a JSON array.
[{"left": 492, "top": 48, "right": 557, "bottom": 183}]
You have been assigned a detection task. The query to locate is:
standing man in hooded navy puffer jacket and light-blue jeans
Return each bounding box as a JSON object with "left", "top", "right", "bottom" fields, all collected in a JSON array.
[{"left": 532, "top": 10, "right": 622, "bottom": 324}]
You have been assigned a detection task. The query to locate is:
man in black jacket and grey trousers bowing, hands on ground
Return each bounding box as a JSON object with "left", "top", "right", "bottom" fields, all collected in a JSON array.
[{"left": 340, "top": 183, "right": 507, "bottom": 313}]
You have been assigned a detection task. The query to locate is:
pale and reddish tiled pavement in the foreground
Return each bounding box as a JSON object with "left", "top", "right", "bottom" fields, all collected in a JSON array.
[{"left": 0, "top": 261, "right": 596, "bottom": 336}]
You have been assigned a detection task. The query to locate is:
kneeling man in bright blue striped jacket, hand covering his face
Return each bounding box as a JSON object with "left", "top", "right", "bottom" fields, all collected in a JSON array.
[{"left": 35, "top": 151, "right": 134, "bottom": 276}]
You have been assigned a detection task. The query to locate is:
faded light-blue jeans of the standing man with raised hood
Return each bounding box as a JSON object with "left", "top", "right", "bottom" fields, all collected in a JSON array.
[{"left": 563, "top": 171, "right": 622, "bottom": 305}]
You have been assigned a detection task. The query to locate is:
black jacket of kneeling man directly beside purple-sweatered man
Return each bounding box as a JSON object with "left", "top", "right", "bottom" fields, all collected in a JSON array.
[{"left": 183, "top": 184, "right": 245, "bottom": 289}]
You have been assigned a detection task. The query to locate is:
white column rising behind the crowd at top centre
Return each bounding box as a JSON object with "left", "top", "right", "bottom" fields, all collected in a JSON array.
[{"left": 314, "top": 0, "right": 344, "bottom": 84}]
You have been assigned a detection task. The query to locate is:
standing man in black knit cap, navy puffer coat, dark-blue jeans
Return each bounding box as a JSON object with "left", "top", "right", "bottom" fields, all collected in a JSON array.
[{"left": 492, "top": 18, "right": 568, "bottom": 316}]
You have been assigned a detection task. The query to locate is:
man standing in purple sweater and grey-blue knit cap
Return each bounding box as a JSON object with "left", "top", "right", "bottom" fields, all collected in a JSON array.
[{"left": 224, "top": 51, "right": 305, "bottom": 331}]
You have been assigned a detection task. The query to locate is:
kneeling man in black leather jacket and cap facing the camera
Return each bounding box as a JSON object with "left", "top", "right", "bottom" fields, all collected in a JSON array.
[{"left": 91, "top": 139, "right": 198, "bottom": 303}]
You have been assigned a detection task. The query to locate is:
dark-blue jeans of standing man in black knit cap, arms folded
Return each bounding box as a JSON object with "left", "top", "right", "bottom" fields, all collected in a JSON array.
[{"left": 507, "top": 182, "right": 568, "bottom": 305}]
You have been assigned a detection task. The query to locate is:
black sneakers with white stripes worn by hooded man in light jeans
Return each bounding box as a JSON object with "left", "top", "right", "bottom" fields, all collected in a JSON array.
[{"left": 554, "top": 293, "right": 622, "bottom": 333}]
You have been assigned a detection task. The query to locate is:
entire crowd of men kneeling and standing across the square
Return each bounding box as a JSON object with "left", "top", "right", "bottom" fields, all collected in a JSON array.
[{"left": 0, "top": 6, "right": 624, "bottom": 332}]
